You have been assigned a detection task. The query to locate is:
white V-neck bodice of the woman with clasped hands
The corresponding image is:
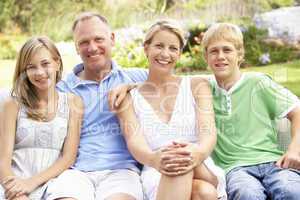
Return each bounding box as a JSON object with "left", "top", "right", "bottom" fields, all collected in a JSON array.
[{"left": 131, "top": 77, "right": 198, "bottom": 150}]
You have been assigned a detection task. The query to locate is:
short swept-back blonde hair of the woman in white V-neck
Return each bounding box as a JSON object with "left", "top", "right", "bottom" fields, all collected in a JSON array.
[{"left": 144, "top": 19, "right": 186, "bottom": 50}]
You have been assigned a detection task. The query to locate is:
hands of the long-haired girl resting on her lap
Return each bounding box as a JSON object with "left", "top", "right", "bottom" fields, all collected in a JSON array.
[{"left": 3, "top": 176, "right": 38, "bottom": 200}]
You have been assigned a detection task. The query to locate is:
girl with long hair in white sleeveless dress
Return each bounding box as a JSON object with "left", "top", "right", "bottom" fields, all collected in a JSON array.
[{"left": 0, "top": 37, "right": 83, "bottom": 200}]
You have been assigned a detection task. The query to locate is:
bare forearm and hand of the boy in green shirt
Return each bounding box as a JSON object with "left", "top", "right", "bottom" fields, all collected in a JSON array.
[{"left": 276, "top": 105, "right": 300, "bottom": 170}]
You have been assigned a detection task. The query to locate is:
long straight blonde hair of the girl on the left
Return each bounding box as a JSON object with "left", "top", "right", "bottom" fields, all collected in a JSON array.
[{"left": 11, "top": 36, "right": 63, "bottom": 119}]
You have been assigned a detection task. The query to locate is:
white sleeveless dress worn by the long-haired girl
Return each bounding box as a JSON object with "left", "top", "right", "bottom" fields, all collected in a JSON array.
[{"left": 0, "top": 93, "right": 69, "bottom": 200}]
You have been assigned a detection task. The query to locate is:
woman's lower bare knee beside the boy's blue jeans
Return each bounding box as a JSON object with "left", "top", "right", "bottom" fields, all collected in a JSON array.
[{"left": 192, "top": 180, "right": 218, "bottom": 200}]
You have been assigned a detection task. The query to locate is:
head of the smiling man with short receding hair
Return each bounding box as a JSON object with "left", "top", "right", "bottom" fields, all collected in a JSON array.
[{"left": 74, "top": 17, "right": 114, "bottom": 72}]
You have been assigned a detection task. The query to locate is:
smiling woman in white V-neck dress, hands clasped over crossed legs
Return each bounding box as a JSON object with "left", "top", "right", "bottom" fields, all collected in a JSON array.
[{"left": 117, "top": 21, "right": 225, "bottom": 200}]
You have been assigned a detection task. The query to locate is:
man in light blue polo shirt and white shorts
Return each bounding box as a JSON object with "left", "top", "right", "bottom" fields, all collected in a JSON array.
[{"left": 45, "top": 12, "right": 147, "bottom": 200}]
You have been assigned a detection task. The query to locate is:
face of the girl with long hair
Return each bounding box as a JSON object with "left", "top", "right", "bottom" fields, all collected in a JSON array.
[{"left": 26, "top": 47, "right": 60, "bottom": 91}]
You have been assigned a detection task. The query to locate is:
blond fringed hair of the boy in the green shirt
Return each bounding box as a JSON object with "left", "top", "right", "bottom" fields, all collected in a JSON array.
[{"left": 202, "top": 23, "right": 245, "bottom": 64}]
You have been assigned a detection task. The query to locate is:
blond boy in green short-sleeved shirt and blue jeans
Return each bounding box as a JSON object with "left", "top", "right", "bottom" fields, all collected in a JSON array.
[{"left": 202, "top": 23, "right": 300, "bottom": 200}]
